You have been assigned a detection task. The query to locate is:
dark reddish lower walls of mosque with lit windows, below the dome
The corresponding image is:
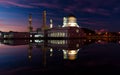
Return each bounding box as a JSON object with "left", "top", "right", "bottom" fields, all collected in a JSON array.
[{"left": 46, "top": 27, "right": 85, "bottom": 38}]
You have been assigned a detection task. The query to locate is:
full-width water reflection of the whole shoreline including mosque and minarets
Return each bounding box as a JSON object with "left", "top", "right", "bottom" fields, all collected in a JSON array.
[{"left": 1, "top": 39, "right": 120, "bottom": 61}]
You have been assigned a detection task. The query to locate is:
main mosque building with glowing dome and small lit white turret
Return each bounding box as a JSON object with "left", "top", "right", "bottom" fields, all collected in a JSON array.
[{"left": 46, "top": 15, "right": 85, "bottom": 38}]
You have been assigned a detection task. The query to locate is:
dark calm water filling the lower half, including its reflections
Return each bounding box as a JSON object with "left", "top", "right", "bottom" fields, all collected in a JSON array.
[{"left": 0, "top": 39, "right": 120, "bottom": 75}]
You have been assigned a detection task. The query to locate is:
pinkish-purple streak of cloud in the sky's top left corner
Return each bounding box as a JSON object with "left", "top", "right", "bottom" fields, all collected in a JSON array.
[{"left": 0, "top": 0, "right": 34, "bottom": 8}]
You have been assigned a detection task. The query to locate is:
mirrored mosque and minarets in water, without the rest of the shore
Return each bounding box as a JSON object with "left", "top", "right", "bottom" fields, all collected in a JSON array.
[{"left": 28, "top": 40, "right": 84, "bottom": 62}]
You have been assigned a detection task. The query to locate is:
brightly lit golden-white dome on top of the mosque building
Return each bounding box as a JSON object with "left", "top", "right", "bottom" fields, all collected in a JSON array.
[{"left": 62, "top": 15, "right": 79, "bottom": 27}]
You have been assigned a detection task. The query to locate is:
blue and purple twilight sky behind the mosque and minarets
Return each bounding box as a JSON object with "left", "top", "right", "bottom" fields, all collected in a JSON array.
[{"left": 0, "top": 0, "right": 120, "bottom": 32}]
